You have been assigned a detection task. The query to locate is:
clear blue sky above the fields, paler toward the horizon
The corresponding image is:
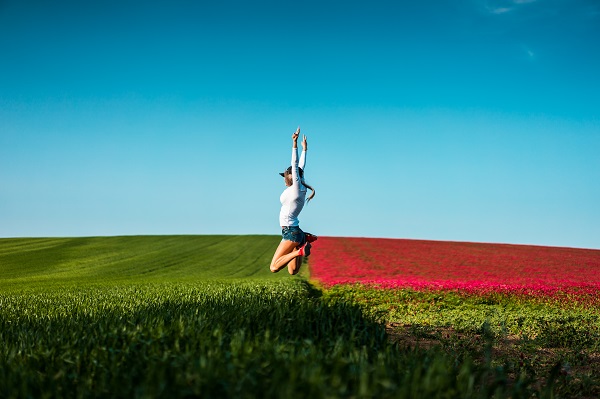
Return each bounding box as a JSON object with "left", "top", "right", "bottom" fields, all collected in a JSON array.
[{"left": 0, "top": 0, "right": 600, "bottom": 248}]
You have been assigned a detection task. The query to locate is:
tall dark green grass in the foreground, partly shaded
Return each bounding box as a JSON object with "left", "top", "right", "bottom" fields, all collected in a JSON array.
[{"left": 0, "top": 279, "right": 564, "bottom": 398}]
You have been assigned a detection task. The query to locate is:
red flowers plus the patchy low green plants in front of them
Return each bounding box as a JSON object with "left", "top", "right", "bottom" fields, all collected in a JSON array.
[{"left": 311, "top": 237, "right": 600, "bottom": 398}]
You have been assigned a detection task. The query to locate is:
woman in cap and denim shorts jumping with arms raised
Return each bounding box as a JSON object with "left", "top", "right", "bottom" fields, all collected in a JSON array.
[{"left": 271, "top": 128, "right": 317, "bottom": 274}]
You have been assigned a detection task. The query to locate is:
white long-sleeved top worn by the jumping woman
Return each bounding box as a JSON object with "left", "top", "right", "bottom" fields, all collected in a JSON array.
[{"left": 279, "top": 148, "right": 306, "bottom": 227}]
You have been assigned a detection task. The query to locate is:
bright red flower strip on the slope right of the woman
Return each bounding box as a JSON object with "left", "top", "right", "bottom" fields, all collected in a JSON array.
[{"left": 310, "top": 237, "right": 600, "bottom": 302}]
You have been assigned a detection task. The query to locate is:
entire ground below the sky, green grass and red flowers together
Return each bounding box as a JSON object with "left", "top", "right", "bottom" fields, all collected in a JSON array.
[{"left": 0, "top": 236, "right": 600, "bottom": 398}]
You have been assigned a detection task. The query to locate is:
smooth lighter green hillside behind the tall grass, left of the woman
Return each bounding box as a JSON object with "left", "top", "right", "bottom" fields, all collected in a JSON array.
[{"left": 0, "top": 236, "right": 278, "bottom": 286}]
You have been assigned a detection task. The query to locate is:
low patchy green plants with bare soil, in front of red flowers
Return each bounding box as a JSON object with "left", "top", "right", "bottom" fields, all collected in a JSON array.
[{"left": 327, "top": 284, "right": 600, "bottom": 398}]
